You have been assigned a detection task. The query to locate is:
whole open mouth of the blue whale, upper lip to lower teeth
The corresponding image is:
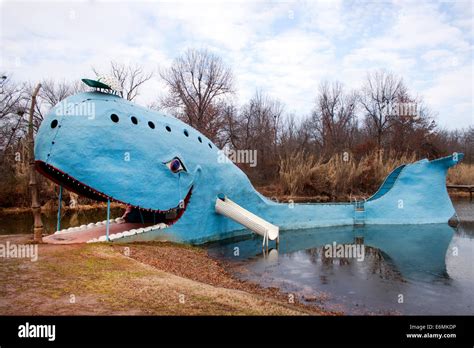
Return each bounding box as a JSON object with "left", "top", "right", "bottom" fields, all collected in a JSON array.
[{"left": 35, "top": 160, "right": 193, "bottom": 243}]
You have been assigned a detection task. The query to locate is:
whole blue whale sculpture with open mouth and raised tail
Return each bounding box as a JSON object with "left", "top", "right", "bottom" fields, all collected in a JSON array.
[{"left": 35, "top": 91, "right": 463, "bottom": 243}]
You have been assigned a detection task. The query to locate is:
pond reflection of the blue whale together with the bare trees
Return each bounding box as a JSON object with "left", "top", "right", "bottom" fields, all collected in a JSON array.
[{"left": 210, "top": 224, "right": 454, "bottom": 280}]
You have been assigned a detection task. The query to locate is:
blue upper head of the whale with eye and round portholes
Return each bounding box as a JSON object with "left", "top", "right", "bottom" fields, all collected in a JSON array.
[{"left": 35, "top": 92, "right": 224, "bottom": 223}]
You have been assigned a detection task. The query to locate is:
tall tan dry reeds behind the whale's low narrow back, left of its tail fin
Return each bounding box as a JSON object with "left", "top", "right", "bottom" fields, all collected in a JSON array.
[{"left": 280, "top": 152, "right": 416, "bottom": 199}]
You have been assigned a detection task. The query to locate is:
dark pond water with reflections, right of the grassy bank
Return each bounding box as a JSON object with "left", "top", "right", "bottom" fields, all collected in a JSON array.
[{"left": 208, "top": 200, "right": 474, "bottom": 315}]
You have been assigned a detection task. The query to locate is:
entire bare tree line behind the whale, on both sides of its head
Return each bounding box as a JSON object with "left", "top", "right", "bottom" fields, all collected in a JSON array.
[{"left": 0, "top": 49, "right": 474, "bottom": 206}]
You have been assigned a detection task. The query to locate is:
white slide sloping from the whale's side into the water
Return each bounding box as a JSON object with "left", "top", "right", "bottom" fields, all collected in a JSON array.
[{"left": 216, "top": 197, "right": 280, "bottom": 243}]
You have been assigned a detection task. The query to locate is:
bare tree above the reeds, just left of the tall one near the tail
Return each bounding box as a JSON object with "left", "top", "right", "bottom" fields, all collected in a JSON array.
[{"left": 309, "top": 82, "right": 357, "bottom": 155}]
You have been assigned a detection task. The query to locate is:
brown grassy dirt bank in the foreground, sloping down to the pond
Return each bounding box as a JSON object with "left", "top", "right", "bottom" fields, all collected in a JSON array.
[{"left": 0, "top": 235, "right": 333, "bottom": 315}]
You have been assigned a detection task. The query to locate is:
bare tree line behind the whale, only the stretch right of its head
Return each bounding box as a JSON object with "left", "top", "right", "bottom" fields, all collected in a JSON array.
[{"left": 156, "top": 49, "right": 474, "bottom": 183}]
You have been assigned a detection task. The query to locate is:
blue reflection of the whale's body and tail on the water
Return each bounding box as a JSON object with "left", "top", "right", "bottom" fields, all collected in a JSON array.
[{"left": 210, "top": 224, "right": 454, "bottom": 281}]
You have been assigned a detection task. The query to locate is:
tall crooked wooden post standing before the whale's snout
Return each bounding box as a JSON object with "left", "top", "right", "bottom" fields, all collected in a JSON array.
[{"left": 28, "top": 83, "right": 43, "bottom": 243}]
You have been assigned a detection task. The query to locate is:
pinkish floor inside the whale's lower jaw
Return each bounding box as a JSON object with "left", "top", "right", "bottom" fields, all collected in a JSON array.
[{"left": 43, "top": 222, "right": 148, "bottom": 244}]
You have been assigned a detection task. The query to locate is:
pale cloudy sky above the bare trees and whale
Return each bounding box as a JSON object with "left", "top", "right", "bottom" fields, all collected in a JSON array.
[{"left": 0, "top": 0, "right": 474, "bottom": 129}]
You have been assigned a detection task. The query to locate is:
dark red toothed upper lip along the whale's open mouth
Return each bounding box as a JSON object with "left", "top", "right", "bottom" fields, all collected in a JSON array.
[{"left": 35, "top": 160, "right": 193, "bottom": 220}]
